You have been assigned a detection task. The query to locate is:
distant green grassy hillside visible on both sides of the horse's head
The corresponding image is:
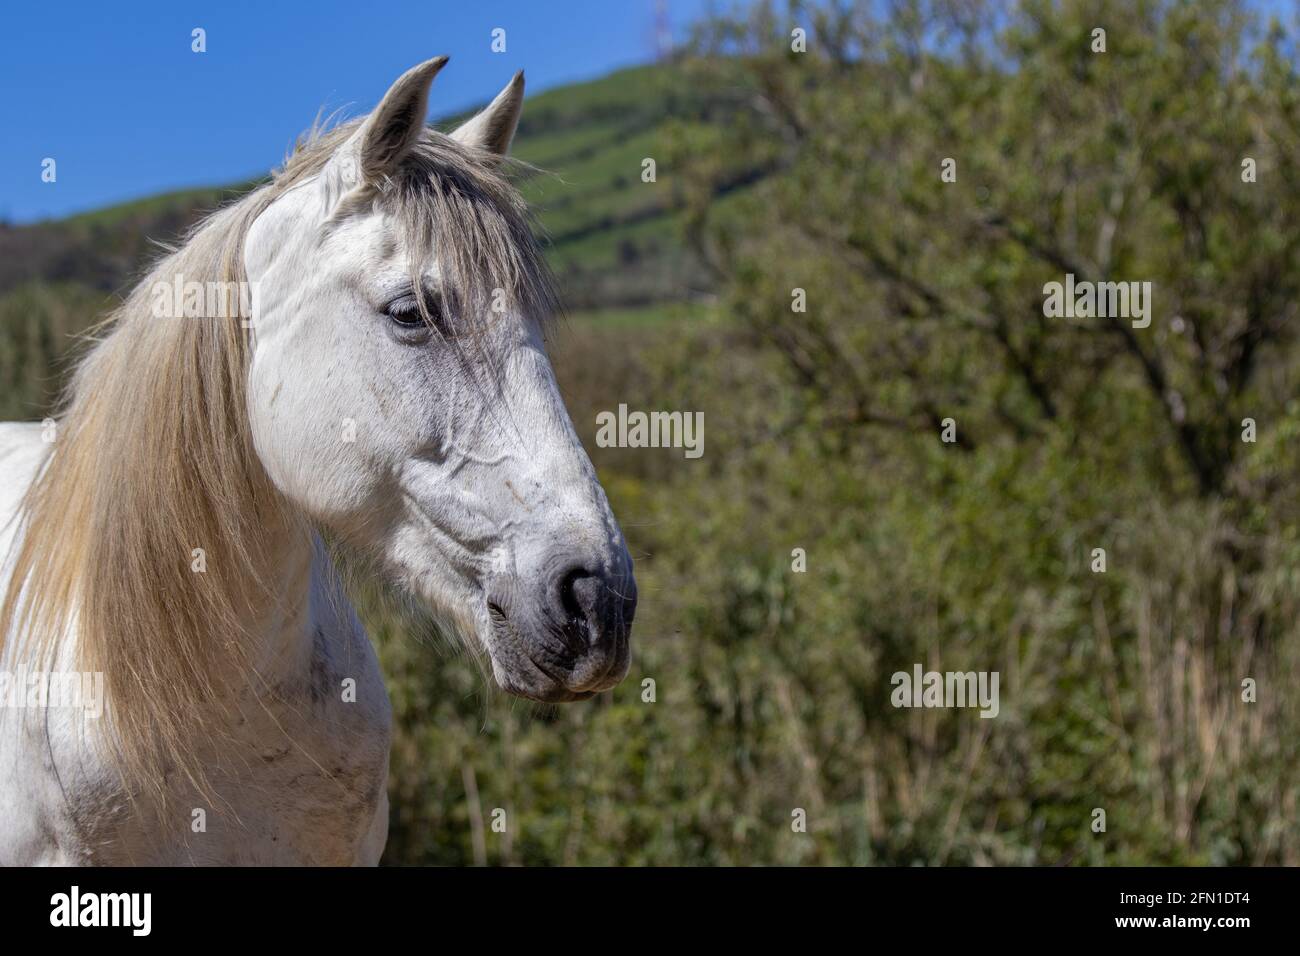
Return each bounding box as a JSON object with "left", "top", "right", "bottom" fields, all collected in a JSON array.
[{"left": 0, "top": 66, "right": 753, "bottom": 419}]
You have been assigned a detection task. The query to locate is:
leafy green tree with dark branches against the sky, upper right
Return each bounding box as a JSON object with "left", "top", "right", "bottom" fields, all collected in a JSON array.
[{"left": 688, "top": 0, "right": 1300, "bottom": 496}]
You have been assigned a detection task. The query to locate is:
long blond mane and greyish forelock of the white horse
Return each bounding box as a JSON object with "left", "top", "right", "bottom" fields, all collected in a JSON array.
[{"left": 0, "top": 120, "right": 555, "bottom": 799}]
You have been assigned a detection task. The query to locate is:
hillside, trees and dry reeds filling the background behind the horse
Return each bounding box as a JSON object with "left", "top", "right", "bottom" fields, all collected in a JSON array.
[{"left": 0, "top": 0, "right": 1300, "bottom": 865}]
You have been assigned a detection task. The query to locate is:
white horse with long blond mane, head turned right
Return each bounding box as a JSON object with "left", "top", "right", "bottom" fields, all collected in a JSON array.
[{"left": 0, "top": 57, "right": 636, "bottom": 865}]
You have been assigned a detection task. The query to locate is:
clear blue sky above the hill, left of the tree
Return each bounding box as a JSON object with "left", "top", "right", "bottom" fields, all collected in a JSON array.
[{"left": 0, "top": 0, "right": 707, "bottom": 222}]
